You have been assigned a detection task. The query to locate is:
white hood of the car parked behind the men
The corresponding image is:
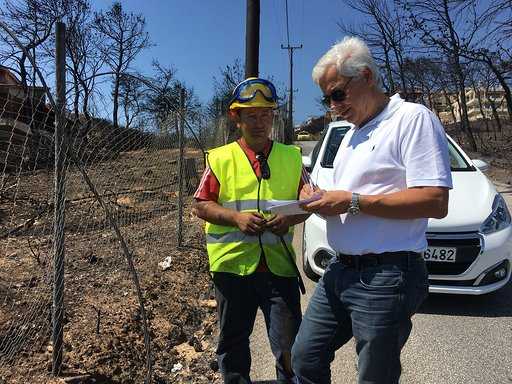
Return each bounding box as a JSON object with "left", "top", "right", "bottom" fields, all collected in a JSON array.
[{"left": 427, "top": 170, "right": 496, "bottom": 232}]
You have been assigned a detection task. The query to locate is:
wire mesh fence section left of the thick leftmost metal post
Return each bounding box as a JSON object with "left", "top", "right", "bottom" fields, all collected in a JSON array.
[{"left": 0, "top": 83, "right": 53, "bottom": 363}]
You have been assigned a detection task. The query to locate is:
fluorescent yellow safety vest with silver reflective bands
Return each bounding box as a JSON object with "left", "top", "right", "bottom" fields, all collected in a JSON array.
[{"left": 205, "top": 142, "right": 302, "bottom": 277}]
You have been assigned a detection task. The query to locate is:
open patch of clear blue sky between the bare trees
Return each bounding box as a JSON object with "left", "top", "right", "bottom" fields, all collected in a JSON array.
[{"left": 93, "top": 0, "right": 360, "bottom": 123}]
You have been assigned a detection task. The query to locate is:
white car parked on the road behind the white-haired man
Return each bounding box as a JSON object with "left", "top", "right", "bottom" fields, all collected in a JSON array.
[{"left": 302, "top": 121, "right": 512, "bottom": 295}]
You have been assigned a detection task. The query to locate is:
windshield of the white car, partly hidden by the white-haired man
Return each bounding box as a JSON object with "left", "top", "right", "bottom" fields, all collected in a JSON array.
[{"left": 320, "top": 126, "right": 475, "bottom": 171}]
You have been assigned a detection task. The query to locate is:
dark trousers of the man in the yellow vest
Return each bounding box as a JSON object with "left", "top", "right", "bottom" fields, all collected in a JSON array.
[{"left": 213, "top": 272, "right": 301, "bottom": 384}]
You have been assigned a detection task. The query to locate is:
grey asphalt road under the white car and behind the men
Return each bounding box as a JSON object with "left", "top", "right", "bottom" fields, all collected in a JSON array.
[{"left": 247, "top": 142, "right": 512, "bottom": 384}]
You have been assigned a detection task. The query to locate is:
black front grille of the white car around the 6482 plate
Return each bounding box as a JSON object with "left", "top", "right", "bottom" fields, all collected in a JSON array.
[{"left": 427, "top": 233, "right": 482, "bottom": 275}]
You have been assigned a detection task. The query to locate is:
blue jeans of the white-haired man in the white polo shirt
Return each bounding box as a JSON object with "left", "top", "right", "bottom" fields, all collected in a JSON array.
[{"left": 292, "top": 253, "right": 428, "bottom": 384}]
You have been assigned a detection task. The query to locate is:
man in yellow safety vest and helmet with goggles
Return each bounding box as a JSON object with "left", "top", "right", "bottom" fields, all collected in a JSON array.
[{"left": 194, "top": 78, "right": 307, "bottom": 383}]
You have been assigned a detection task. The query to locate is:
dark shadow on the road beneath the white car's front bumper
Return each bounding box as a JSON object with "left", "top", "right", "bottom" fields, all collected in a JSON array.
[{"left": 418, "top": 281, "right": 512, "bottom": 317}]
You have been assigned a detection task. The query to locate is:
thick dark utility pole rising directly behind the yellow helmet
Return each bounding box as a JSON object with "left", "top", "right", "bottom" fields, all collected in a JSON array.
[{"left": 245, "top": 0, "right": 260, "bottom": 79}]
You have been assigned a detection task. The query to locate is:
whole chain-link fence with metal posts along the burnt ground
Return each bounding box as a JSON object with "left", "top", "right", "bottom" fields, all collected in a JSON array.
[{"left": 0, "top": 21, "right": 230, "bottom": 383}]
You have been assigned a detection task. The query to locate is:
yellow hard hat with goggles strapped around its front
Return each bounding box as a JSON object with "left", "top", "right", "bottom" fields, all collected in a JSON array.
[{"left": 229, "top": 77, "right": 277, "bottom": 109}]
